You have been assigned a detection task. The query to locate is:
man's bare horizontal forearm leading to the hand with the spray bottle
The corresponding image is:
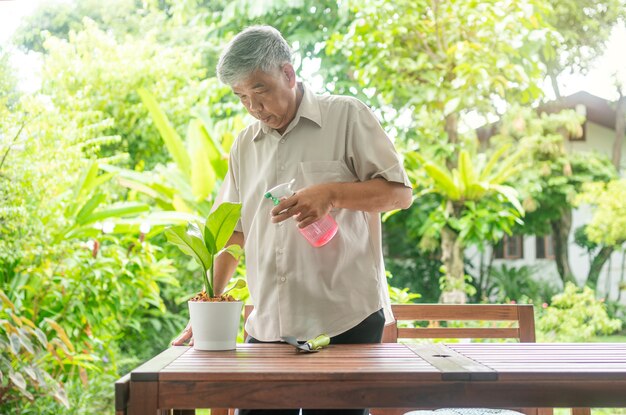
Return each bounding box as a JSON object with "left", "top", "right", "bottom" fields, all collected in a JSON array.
[{"left": 325, "top": 178, "right": 412, "bottom": 212}]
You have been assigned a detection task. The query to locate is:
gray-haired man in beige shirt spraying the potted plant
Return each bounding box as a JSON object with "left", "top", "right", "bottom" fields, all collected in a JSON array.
[{"left": 174, "top": 26, "right": 412, "bottom": 414}]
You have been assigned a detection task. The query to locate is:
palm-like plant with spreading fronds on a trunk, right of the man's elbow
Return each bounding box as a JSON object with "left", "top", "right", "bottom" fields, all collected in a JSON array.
[{"left": 407, "top": 147, "right": 524, "bottom": 303}]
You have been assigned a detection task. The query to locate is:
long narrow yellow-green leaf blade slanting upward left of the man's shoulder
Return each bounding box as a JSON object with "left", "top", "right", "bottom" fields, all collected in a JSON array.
[{"left": 137, "top": 88, "right": 191, "bottom": 178}]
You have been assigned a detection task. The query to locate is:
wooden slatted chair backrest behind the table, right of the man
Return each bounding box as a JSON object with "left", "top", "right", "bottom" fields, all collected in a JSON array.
[{"left": 383, "top": 304, "right": 535, "bottom": 343}]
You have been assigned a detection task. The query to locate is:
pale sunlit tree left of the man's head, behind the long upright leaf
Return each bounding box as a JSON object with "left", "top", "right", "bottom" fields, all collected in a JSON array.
[{"left": 42, "top": 20, "right": 217, "bottom": 170}]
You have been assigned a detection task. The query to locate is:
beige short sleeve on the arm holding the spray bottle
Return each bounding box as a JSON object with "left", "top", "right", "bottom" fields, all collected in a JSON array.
[{"left": 346, "top": 101, "right": 411, "bottom": 187}]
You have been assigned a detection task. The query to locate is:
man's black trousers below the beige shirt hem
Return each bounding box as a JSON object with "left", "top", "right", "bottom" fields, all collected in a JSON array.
[{"left": 237, "top": 309, "right": 385, "bottom": 415}]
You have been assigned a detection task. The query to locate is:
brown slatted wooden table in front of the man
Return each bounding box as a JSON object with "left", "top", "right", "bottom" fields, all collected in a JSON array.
[{"left": 116, "top": 343, "right": 626, "bottom": 415}]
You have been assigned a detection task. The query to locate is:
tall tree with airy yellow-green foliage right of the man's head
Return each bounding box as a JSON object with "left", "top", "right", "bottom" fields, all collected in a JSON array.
[{"left": 326, "top": 0, "right": 550, "bottom": 300}]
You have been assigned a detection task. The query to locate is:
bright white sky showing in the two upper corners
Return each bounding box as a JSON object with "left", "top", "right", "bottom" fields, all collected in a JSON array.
[{"left": 0, "top": 0, "right": 626, "bottom": 100}]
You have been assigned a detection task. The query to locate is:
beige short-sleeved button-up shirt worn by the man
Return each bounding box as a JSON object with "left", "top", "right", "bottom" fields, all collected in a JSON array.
[{"left": 218, "top": 85, "right": 411, "bottom": 341}]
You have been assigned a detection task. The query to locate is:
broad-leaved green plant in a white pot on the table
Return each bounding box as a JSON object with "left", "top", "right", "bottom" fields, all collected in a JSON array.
[{"left": 165, "top": 203, "right": 246, "bottom": 350}]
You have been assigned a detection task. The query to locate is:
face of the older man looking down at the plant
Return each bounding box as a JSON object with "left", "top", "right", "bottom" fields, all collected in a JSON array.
[{"left": 232, "top": 64, "right": 298, "bottom": 134}]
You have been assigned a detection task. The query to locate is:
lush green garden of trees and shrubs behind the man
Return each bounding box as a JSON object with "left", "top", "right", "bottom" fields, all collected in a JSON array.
[{"left": 0, "top": 0, "right": 626, "bottom": 415}]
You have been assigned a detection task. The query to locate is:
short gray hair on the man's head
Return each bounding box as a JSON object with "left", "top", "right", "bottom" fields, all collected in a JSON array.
[{"left": 217, "top": 26, "right": 292, "bottom": 86}]
